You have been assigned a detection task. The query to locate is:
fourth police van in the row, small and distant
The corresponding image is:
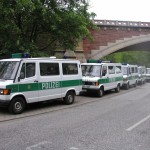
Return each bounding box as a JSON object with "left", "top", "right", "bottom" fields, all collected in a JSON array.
[{"left": 138, "top": 66, "right": 146, "bottom": 85}]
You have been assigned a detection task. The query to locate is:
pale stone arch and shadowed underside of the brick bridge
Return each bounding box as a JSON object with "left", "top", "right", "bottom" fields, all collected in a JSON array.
[{"left": 89, "top": 34, "right": 150, "bottom": 59}]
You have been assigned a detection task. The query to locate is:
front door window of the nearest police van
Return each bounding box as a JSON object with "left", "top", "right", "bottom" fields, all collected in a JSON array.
[{"left": 20, "top": 63, "right": 35, "bottom": 79}]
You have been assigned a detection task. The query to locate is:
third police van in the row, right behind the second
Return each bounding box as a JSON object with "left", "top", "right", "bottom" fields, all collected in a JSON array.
[{"left": 122, "top": 64, "right": 138, "bottom": 90}]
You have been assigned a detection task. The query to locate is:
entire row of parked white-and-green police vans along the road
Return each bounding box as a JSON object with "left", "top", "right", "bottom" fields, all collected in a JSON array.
[{"left": 0, "top": 53, "right": 150, "bottom": 114}]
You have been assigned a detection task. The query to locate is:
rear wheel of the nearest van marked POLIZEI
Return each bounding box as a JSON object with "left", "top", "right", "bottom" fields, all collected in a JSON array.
[{"left": 64, "top": 91, "right": 75, "bottom": 105}]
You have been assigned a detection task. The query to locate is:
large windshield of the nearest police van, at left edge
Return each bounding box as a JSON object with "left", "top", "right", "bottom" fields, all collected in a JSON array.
[{"left": 0, "top": 61, "right": 19, "bottom": 80}]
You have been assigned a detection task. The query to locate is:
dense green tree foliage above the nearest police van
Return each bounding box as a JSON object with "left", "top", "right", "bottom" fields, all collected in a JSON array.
[{"left": 0, "top": 0, "right": 95, "bottom": 56}]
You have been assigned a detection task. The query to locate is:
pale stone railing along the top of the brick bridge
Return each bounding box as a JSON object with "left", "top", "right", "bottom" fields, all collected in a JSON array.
[{"left": 94, "top": 20, "right": 150, "bottom": 28}]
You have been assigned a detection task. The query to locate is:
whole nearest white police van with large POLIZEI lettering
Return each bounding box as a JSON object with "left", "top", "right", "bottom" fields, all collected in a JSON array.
[{"left": 0, "top": 53, "right": 82, "bottom": 114}]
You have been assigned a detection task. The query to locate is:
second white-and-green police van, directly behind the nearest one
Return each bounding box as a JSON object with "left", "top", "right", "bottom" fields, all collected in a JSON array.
[{"left": 81, "top": 60, "right": 123, "bottom": 97}]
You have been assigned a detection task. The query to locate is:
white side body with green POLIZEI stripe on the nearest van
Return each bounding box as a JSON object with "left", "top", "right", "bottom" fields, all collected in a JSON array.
[{"left": 7, "top": 59, "right": 82, "bottom": 103}]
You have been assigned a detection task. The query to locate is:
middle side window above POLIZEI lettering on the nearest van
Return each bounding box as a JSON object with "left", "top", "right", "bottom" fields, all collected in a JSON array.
[{"left": 40, "top": 63, "right": 59, "bottom": 76}]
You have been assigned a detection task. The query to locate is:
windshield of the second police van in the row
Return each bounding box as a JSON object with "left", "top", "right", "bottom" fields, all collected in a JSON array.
[{"left": 81, "top": 65, "right": 101, "bottom": 77}]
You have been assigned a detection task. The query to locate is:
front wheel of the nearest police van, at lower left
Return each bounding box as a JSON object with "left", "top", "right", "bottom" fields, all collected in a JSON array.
[{"left": 8, "top": 97, "right": 26, "bottom": 114}]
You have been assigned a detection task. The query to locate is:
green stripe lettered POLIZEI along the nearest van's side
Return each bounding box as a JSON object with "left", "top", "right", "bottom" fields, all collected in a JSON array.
[{"left": 6, "top": 79, "right": 82, "bottom": 93}]
